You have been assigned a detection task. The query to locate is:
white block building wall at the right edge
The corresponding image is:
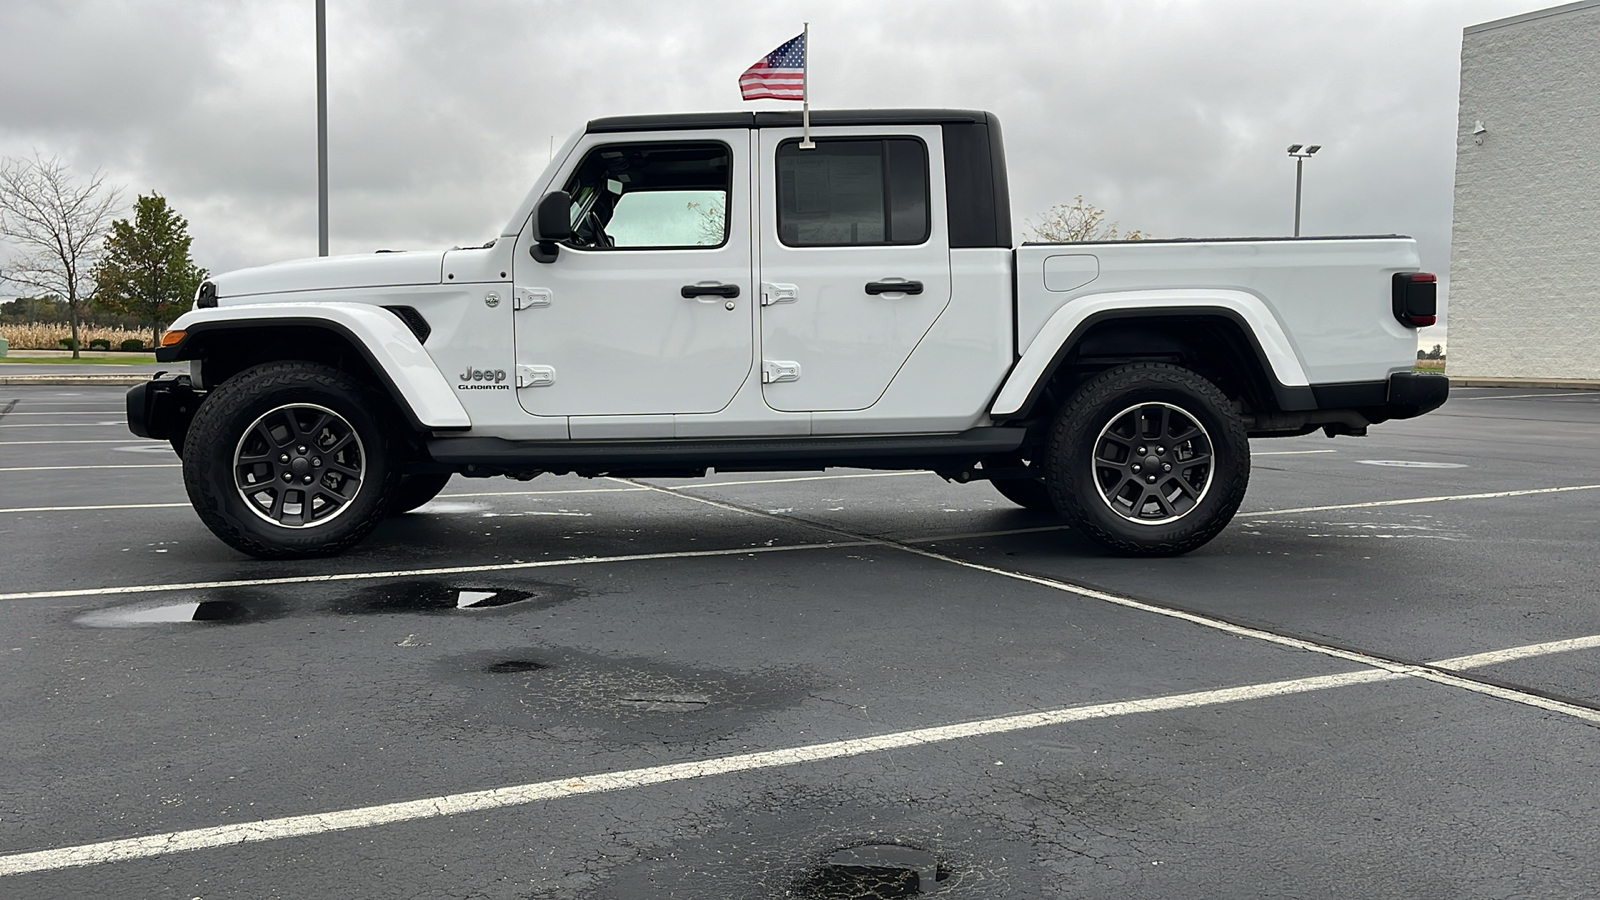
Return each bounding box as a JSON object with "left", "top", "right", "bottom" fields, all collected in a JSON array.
[{"left": 1450, "top": 0, "right": 1600, "bottom": 378}]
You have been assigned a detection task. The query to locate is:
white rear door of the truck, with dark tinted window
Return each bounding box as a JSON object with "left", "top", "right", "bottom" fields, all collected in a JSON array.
[{"left": 758, "top": 125, "right": 950, "bottom": 412}]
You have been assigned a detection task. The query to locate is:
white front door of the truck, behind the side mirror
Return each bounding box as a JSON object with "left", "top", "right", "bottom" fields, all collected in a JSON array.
[{"left": 512, "top": 130, "right": 758, "bottom": 416}]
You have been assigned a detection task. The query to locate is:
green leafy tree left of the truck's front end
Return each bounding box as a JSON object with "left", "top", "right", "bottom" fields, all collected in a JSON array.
[{"left": 94, "top": 191, "right": 206, "bottom": 344}]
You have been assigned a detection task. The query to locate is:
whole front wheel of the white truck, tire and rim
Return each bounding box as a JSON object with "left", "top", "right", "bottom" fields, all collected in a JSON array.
[{"left": 184, "top": 362, "right": 400, "bottom": 559}]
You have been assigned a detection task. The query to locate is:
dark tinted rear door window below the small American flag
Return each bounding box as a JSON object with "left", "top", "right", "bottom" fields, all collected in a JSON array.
[{"left": 778, "top": 138, "right": 931, "bottom": 247}]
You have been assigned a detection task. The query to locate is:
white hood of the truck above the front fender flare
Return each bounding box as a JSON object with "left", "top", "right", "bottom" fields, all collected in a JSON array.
[{"left": 210, "top": 251, "right": 445, "bottom": 299}]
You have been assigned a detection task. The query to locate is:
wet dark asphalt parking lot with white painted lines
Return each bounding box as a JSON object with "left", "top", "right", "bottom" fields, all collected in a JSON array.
[{"left": 0, "top": 386, "right": 1600, "bottom": 900}]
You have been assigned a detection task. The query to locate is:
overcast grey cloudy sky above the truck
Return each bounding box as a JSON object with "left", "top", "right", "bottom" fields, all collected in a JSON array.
[{"left": 0, "top": 0, "right": 1554, "bottom": 333}]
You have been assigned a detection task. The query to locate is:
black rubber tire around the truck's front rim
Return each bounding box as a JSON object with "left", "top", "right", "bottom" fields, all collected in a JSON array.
[{"left": 182, "top": 362, "right": 402, "bottom": 559}]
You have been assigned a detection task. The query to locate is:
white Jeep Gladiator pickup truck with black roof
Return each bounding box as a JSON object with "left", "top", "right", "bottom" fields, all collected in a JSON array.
[{"left": 128, "top": 110, "right": 1448, "bottom": 557}]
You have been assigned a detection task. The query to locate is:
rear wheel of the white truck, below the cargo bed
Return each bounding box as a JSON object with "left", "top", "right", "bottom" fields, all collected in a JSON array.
[{"left": 1045, "top": 362, "right": 1250, "bottom": 556}]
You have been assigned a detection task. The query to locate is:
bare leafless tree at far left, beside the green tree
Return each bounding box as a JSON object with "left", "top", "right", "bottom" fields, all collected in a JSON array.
[{"left": 0, "top": 154, "right": 122, "bottom": 359}]
